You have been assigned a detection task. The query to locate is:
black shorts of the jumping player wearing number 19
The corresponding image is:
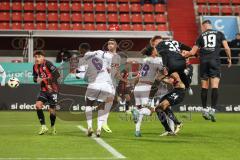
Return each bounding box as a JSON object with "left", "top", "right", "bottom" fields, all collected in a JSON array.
[{"left": 200, "top": 58, "right": 221, "bottom": 80}]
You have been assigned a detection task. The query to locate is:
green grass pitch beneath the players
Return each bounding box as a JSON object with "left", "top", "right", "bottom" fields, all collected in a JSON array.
[{"left": 0, "top": 112, "right": 240, "bottom": 160}]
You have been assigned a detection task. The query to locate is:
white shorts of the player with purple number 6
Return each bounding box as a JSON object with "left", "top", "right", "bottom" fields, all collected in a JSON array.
[{"left": 85, "top": 83, "right": 114, "bottom": 102}]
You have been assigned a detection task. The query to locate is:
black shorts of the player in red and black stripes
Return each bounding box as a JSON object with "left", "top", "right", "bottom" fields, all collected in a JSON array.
[{"left": 37, "top": 91, "right": 58, "bottom": 108}]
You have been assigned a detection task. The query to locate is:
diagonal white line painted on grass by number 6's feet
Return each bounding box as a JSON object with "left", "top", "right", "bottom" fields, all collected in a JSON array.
[{"left": 78, "top": 125, "right": 126, "bottom": 159}]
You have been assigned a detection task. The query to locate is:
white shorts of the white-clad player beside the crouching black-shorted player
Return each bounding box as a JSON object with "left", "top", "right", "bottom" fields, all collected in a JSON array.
[{"left": 134, "top": 83, "right": 152, "bottom": 106}]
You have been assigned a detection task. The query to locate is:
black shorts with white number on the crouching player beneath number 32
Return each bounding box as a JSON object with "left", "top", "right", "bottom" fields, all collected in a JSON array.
[{"left": 161, "top": 88, "right": 185, "bottom": 106}]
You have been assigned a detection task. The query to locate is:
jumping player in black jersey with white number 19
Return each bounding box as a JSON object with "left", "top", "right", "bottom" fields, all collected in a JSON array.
[{"left": 182, "top": 20, "right": 232, "bottom": 122}]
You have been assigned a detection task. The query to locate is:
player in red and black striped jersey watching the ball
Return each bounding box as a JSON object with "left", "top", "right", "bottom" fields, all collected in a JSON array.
[{"left": 33, "top": 51, "right": 60, "bottom": 135}]
